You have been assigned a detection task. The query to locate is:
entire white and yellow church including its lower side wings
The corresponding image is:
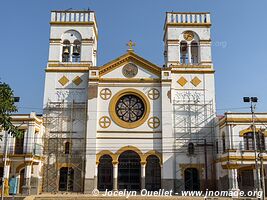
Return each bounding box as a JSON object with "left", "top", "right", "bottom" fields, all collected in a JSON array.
[{"left": 0, "top": 10, "right": 267, "bottom": 195}]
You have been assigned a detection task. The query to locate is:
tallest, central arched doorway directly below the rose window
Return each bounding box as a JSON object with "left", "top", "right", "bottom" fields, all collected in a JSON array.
[{"left": 118, "top": 151, "right": 141, "bottom": 191}]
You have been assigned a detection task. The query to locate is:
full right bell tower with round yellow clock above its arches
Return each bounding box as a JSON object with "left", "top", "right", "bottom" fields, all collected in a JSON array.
[{"left": 162, "top": 12, "right": 215, "bottom": 191}]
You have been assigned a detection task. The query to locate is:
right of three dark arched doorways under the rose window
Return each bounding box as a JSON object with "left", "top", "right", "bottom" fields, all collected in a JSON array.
[{"left": 146, "top": 155, "right": 161, "bottom": 191}]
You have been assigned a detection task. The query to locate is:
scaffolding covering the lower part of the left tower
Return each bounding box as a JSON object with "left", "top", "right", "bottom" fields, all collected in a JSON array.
[{"left": 42, "top": 101, "right": 87, "bottom": 193}]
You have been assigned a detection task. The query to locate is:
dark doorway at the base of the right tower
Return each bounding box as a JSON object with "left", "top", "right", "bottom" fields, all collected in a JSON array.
[{"left": 184, "top": 168, "right": 200, "bottom": 191}]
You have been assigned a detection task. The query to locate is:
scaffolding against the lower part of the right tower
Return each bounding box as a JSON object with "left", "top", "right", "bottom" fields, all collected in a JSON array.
[{"left": 173, "top": 93, "right": 218, "bottom": 189}]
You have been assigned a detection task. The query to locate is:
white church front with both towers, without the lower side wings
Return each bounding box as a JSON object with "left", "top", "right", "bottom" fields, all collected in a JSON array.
[{"left": 43, "top": 11, "right": 218, "bottom": 192}]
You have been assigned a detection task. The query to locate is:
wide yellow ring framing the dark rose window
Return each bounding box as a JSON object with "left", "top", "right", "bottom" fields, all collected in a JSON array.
[{"left": 109, "top": 88, "right": 150, "bottom": 129}]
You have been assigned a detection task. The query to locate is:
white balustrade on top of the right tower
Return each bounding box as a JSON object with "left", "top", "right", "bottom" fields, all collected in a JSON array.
[{"left": 166, "top": 12, "right": 210, "bottom": 24}]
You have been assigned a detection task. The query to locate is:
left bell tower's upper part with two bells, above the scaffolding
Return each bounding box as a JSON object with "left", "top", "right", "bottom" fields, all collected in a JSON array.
[{"left": 44, "top": 10, "right": 98, "bottom": 106}]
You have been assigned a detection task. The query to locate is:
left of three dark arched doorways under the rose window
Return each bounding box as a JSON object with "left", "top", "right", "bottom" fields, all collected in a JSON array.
[{"left": 97, "top": 155, "right": 113, "bottom": 191}]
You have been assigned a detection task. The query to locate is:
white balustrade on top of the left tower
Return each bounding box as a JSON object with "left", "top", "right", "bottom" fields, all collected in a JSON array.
[{"left": 51, "top": 11, "right": 96, "bottom": 22}]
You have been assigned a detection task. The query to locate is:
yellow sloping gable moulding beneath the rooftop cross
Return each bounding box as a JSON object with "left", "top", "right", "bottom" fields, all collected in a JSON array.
[{"left": 99, "top": 51, "right": 161, "bottom": 77}]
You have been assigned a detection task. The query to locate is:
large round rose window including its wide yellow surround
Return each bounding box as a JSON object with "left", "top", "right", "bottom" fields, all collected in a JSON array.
[{"left": 109, "top": 89, "right": 150, "bottom": 129}]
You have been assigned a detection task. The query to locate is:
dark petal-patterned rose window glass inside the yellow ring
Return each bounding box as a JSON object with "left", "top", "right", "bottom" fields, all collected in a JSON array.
[{"left": 115, "top": 94, "right": 145, "bottom": 123}]
